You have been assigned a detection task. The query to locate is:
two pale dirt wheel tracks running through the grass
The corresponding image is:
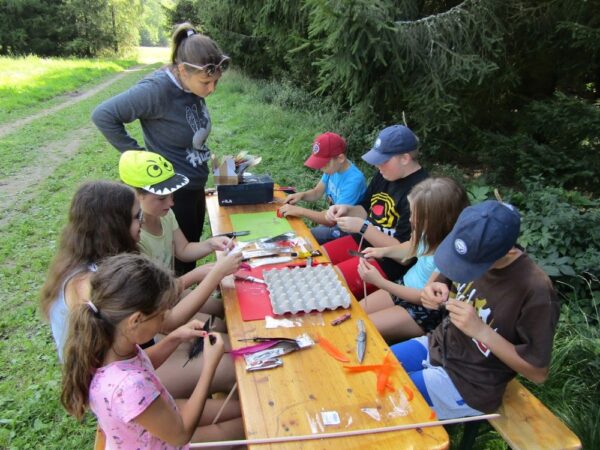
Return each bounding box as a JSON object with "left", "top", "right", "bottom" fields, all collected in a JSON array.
[{"left": 0, "top": 66, "right": 145, "bottom": 229}]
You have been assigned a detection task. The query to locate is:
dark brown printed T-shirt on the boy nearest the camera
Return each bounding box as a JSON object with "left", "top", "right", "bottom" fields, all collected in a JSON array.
[{"left": 429, "top": 253, "right": 560, "bottom": 413}]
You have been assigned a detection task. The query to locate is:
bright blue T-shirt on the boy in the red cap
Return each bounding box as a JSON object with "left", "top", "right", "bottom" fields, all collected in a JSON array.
[{"left": 321, "top": 163, "right": 367, "bottom": 205}]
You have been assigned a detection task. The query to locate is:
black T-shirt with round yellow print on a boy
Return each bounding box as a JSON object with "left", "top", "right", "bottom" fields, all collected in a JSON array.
[{"left": 354, "top": 168, "right": 429, "bottom": 281}]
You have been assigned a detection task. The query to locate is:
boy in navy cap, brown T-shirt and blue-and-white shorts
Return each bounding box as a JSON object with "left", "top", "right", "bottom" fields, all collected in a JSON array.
[{"left": 392, "top": 201, "right": 560, "bottom": 419}]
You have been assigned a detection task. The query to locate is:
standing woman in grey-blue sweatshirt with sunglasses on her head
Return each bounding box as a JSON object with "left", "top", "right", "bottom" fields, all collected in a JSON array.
[{"left": 92, "top": 23, "right": 229, "bottom": 274}]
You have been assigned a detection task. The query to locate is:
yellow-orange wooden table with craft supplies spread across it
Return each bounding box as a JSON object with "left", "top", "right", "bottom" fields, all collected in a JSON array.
[{"left": 206, "top": 192, "right": 449, "bottom": 450}]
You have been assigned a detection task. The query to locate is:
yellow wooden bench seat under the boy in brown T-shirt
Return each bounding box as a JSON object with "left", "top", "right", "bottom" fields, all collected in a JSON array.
[{"left": 460, "top": 380, "right": 581, "bottom": 450}]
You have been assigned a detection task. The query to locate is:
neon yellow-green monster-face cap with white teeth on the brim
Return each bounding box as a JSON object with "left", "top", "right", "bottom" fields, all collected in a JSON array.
[{"left": 119, "top": 150, "right": 190, "bottom": 195}]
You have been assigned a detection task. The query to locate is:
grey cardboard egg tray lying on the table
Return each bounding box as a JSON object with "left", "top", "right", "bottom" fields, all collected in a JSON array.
[{"left": 263, "top": 265, "right": 350, "bottom": 314}]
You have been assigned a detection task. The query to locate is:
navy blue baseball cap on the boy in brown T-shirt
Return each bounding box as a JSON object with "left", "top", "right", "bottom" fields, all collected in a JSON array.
[{"left": 433, "top": 200, "right": 521, "bottom": 283}]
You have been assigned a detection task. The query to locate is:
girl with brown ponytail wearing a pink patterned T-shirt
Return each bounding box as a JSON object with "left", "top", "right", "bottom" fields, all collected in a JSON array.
[{"left": 61, "top": 254, "right": 243, "bottom": 449}]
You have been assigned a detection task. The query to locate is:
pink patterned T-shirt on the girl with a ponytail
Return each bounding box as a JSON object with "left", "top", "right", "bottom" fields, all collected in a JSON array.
[{"left": 90, "top": 347, "right": 189, "bottom": 450}]
